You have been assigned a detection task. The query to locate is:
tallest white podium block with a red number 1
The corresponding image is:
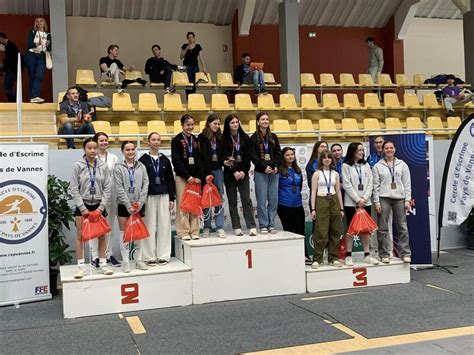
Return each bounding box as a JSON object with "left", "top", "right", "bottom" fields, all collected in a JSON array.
[{"left": 175, "top": 232, "right": 305, "bottom": 304}]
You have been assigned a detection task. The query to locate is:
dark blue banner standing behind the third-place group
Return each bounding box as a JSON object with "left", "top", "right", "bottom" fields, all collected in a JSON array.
[{"left": 370, "top": 133, "right": 432, "bottom": 265}]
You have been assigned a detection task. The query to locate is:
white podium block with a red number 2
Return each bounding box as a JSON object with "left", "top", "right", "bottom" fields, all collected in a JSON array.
[{"left": 60, "top": 258, "right": 192, "bottom": 318}]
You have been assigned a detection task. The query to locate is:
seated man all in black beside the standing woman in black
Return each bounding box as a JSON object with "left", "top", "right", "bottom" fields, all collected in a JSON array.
[{"left": 145, "top": 44, "right": 186, "bottom": 94}]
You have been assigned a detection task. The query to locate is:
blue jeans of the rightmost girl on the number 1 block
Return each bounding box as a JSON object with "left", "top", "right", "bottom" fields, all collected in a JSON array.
[{"left": 254, "top": 172, "right": 279, "bottom": 228}]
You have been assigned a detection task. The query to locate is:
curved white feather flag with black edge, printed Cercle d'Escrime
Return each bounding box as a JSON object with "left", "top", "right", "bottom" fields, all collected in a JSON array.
[{"left": 438, "top": 114, "right": 474, "bottom": 227}]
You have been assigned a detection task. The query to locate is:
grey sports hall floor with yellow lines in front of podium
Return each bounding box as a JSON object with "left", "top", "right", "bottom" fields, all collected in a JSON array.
[{"left": 0, "top": 249, "right": 474, "bottom": 355}]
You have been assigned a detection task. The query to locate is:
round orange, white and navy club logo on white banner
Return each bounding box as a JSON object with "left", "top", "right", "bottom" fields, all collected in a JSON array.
[{"left": 0, "top": 180, "right": 47, "bottom": 244}]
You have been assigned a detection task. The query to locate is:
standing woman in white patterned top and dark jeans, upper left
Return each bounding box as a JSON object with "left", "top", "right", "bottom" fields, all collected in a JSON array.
[{"left": 25, "top": 17, "right": 51, "bottom": 103}]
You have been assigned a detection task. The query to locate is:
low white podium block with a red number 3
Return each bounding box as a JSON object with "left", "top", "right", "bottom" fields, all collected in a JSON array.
[{"left": 306, "top": 259, "right": 410, "bottom": 292}]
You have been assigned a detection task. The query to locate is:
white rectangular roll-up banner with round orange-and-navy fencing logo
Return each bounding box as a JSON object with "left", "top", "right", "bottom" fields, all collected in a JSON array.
[{"left": 0, "top": 143, "right": 51, "bottom": 306}]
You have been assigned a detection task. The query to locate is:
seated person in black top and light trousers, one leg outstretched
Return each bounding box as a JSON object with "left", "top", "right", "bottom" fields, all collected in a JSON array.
[{"left": 99, "top": 44, "right": 146, "bottom": 93}]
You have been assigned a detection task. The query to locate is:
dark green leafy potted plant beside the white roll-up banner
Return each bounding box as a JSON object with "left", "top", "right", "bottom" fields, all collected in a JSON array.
[{"left": 48, "top": 175, "right": 74, "bottom": 296}]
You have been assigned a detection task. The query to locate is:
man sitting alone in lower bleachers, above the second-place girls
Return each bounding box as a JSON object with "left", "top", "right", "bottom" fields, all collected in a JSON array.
[{"left": 59, "top": 87, "right": 95, "bottom": 149}]
